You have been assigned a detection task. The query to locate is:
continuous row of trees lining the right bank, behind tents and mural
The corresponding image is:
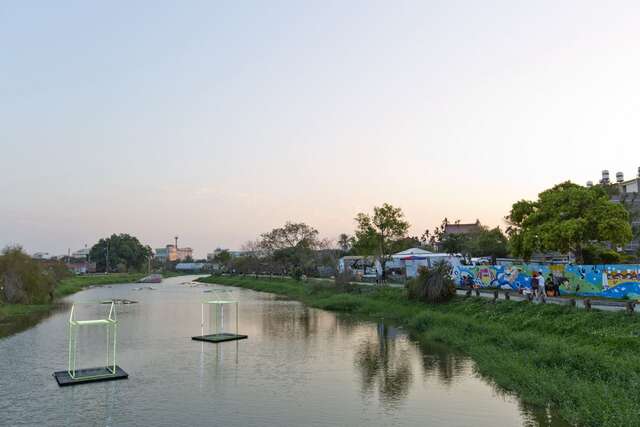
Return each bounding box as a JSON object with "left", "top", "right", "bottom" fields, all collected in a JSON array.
[{"left": 214, "top": 182, "right": 637, "bottom": 277}]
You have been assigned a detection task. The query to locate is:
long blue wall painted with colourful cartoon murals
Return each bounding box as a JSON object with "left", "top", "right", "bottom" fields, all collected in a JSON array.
[{"left": 453, "top": 264, "right": 640, "bottom": 299}]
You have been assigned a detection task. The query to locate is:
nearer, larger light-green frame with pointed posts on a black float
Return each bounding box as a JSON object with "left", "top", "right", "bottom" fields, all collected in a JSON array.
[{"left": 53, "top": 301, "right": 129, "bottom": 386}]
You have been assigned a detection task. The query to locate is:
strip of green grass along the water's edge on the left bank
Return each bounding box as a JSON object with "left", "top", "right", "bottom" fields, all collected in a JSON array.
[{"left": 0, "top": 273, "right": 177, "bottom": 338}]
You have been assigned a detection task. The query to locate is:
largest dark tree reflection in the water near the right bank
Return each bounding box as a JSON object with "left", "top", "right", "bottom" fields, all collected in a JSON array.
[{"left": 354, "top": 323, "right": 413, "bottom": 409}]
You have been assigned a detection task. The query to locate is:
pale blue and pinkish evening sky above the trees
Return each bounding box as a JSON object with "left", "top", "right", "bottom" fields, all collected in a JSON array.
[{"left": 0, "top": 0, "right": 640, "bottom": 257}]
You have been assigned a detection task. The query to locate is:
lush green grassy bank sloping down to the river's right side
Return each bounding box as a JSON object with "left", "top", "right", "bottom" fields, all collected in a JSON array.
[{"left": 202, "top": 277, "right": 640, "bottom": 426}]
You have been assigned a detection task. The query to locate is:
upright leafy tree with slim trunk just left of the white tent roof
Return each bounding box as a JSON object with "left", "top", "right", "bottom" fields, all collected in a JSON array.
[{"left": 354, "top": 203, "right": 409, "bottom": 280}]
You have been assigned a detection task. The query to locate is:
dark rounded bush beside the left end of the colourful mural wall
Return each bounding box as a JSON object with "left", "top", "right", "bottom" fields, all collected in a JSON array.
[{"left": 406, "top": 261, "right": 456, "bottom": 303}]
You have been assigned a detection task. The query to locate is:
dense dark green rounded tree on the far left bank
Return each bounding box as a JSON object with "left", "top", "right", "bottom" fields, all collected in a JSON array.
[{"left": 89, "top": 234, "right": 153, "bottom": 271}]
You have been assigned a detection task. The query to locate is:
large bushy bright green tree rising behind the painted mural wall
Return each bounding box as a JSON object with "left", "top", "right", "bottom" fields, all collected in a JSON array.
[{"left": 506, "top": 182, "right": 632, "bottom": 263}]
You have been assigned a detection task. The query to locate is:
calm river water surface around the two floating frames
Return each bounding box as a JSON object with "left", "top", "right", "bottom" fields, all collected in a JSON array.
[{"left": 0, "top": 277, "right": 565, "bottom": 427}]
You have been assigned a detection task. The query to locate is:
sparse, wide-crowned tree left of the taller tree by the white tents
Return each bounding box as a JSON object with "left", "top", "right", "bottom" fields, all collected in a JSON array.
[{"left": 259, "top": 222, "right": 326, "bottom": 277}]
